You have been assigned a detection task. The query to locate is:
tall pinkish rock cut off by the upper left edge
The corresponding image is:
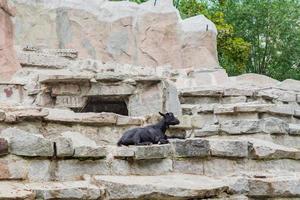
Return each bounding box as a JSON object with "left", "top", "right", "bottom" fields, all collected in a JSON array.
[{"left": 0, "top": 0, "right": 21, "bottom": 81}]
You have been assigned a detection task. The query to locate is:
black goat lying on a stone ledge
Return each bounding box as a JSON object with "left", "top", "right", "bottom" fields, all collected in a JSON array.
[{"left": 118, "top": 112, "right": 180, "bottom": 146}]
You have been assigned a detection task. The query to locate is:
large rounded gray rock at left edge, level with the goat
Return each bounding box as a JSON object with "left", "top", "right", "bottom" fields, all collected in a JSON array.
[{"left": 0, "top": 128, "right": 54, "bottom": 157}]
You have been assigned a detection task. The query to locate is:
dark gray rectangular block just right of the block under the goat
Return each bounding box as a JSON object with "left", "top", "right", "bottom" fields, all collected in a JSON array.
[{"left": 170, "top": 139, "right": 209, "bottom": 157}]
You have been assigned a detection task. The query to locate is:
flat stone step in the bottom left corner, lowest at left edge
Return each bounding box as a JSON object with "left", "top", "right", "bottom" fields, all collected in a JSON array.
[{"left": 0, "top": 181, "right": 106, "bottom": 200}]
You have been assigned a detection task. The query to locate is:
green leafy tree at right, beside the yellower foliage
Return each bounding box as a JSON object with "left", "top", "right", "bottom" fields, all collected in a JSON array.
[{"left": 223, "top": 0, "right": 300, "bottom": 80}]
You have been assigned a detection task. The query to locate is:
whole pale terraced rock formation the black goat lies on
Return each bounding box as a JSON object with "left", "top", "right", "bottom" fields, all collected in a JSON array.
[{"left": 0, "top": 0, "right": 300, "bottom": 200}]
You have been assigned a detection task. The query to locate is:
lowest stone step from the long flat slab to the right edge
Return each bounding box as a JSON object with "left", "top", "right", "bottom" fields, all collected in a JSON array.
[{"left": 92, "top": 171, "right": 300, "bottom": 200}]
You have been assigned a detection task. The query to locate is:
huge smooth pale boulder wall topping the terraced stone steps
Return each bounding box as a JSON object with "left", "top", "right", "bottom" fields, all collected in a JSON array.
[{"left": 14, "top": 0, "right": 219, "bottom": 68}]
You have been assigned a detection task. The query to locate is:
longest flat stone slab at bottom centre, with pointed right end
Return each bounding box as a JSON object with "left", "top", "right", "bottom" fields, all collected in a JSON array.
[{"left": 94, "top": 174, "right": 229, "bottom": 200}]
